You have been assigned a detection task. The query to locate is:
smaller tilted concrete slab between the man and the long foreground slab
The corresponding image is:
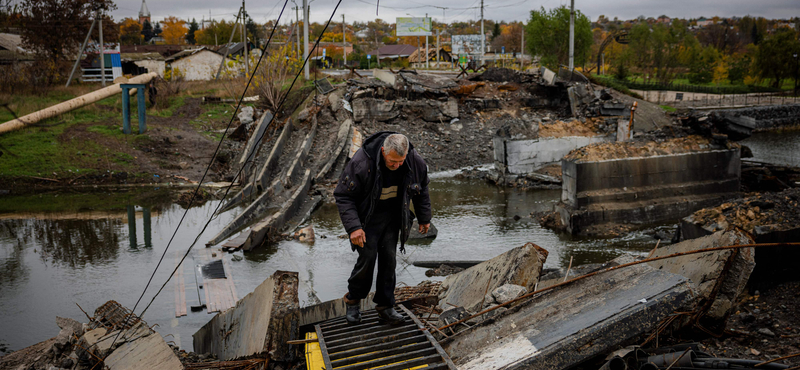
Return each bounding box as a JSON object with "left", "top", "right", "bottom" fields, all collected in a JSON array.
[{"left": 439, "top": 243, "right": 548, "bottom": 312}]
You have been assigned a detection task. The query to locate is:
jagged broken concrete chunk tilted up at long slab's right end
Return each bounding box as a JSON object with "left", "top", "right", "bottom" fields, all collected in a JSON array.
[{"left": 648, "top": 230, "right": 755, "bottom": 327}]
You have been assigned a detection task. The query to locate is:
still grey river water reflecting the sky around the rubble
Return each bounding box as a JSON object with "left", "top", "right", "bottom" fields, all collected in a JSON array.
[{"left": 0, "top": 130, "right": 800, "bottom": 354}]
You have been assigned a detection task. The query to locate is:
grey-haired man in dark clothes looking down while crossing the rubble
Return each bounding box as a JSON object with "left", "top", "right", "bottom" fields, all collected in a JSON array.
[{"left": 333, "top": 131, "right": 431, "bottom": 325}]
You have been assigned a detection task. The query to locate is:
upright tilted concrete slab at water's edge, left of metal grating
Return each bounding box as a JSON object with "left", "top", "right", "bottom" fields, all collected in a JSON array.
[{"left": 192, "top": 271, "right": 299, "bottom": 360}]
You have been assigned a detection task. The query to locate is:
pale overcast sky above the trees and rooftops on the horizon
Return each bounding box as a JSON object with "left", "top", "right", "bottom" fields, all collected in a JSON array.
[{"left": 112, "top": 0, "right": 800, "bottom": 23}]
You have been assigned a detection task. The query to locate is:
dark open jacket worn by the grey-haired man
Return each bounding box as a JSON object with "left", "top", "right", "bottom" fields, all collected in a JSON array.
[{"left": 333, "top": 131, "right": 431, "bottom": 251}]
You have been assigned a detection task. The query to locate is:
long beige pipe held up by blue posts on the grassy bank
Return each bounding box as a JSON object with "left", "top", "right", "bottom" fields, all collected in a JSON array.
[{"left": 0, "top": 72, "right": 158, "bottom": 134}]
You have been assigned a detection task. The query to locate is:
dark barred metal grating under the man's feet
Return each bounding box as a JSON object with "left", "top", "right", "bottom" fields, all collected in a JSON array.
[{"left": 314, "top": 305, "right": 456, "bottom": 370}]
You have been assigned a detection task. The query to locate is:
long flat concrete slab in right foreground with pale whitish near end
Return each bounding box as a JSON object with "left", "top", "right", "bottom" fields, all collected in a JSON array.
[{"left": 442, "top": 257, "right": 693, "bottom": 370}]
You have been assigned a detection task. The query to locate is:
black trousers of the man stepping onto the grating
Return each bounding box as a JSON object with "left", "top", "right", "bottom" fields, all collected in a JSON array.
[{"left": 347, "top": 209, "right": 400, "bottom": 307}]
